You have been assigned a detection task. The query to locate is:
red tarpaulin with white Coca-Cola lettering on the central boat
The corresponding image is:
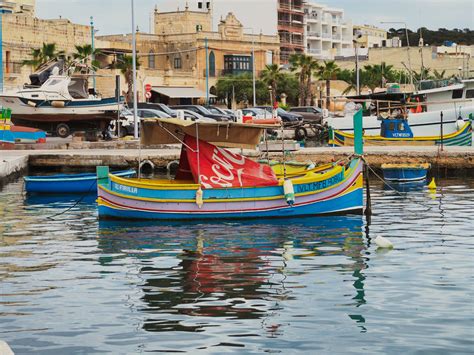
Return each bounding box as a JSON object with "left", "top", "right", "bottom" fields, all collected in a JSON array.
[{"left": 176, "top": 136, "right": 278, "bottom": 189}]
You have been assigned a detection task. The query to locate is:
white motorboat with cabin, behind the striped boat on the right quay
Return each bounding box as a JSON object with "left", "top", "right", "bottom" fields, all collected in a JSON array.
[{"left": 324, "top": 79, "right": 474, "bottom": 136}]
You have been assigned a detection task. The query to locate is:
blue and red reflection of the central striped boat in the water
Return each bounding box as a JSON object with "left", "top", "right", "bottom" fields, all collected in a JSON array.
[{"left": 98, "top": 216, "right": 366, "bottom": 335}]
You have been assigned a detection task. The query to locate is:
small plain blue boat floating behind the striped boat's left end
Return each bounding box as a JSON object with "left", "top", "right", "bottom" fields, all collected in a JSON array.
[{"left": 24, "top": 170, "right": 136, "bottom": 194}]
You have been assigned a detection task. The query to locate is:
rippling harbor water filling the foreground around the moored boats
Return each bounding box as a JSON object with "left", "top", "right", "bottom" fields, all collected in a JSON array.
[{"left": 0, "top": 178, "right": 474, "bottom": 354}]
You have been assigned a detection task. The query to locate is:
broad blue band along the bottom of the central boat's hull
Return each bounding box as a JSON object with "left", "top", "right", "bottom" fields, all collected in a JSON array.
[{"left": 99, "top": 188, "right": 363, "bottom": 220}]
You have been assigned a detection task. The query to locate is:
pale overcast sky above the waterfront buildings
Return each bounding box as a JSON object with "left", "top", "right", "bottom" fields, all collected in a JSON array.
[{"left": 36, "top": 0, "right": 474, "bottom": 35}]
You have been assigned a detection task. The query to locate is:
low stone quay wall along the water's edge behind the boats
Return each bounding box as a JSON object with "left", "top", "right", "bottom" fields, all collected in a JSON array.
[{"left": 0, "top": 146, "right": 474, "bottom": 179}]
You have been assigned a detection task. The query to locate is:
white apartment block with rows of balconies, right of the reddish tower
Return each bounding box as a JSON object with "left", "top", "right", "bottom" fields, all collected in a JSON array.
[{"left": 304, "top": 2, "right": 355, "bottom": 60}]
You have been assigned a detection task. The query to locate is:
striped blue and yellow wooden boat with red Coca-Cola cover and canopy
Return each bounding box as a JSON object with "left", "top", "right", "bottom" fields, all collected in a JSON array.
[{"left": 97, "top": 119, "right": 363, "bottom": 220}]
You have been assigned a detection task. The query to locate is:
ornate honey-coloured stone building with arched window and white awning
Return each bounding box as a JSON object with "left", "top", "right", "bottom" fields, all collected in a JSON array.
[{"left": 98, "top": 7, "right": 279, "bottom": 104}]
